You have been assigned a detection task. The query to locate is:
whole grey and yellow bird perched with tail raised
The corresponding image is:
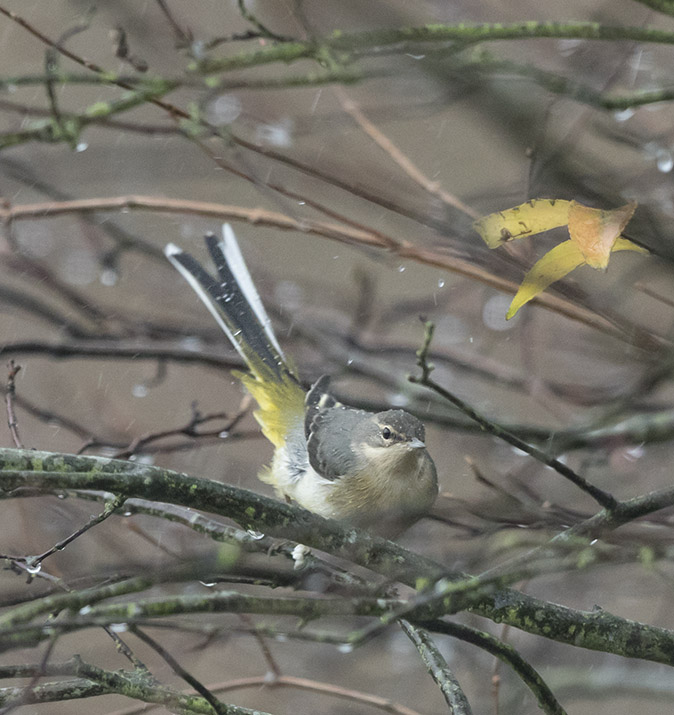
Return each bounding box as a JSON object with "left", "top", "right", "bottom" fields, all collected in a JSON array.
[{"left": 165, "top": 224, "right": 438, "bottom": 537}]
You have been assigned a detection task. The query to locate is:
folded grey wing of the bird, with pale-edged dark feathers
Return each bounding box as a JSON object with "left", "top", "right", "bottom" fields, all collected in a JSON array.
[{"left": 304, "top": 375, "right": 370, "bottom": 480}]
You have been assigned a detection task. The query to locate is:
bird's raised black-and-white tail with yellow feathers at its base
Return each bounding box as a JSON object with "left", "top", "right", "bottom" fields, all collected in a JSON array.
[{"left": 164, "top": 224, "right": 304, "bottom": 447}]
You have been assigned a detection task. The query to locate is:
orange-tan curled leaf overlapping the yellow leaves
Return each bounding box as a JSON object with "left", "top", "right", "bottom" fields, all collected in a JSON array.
[{"left": 569, "top": 201, "right": 637, "bottom": 270}]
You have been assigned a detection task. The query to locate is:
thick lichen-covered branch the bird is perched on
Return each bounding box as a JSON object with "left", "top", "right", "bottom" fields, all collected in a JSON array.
[{"left": 0, "top": 448, "right": 674, "bottom": 665}]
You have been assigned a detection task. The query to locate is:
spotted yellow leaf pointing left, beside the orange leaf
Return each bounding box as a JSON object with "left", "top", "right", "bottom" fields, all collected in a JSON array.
[{"left": 473, "top": 199, "right": 573, "bottom": 248}]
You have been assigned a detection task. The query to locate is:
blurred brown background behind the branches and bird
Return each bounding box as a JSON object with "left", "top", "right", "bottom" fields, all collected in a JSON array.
[{"left": 0, "top": 0, "right": 674, "bottom": 715}]
